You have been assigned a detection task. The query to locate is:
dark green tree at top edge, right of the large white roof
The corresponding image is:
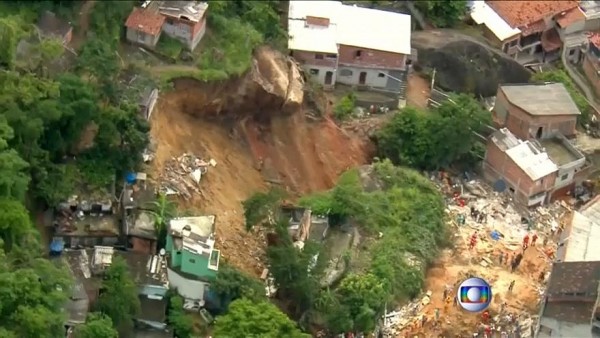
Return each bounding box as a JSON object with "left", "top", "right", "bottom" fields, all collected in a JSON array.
[{"left": 415, "top": 0, "right": 468, "bottom": 28}]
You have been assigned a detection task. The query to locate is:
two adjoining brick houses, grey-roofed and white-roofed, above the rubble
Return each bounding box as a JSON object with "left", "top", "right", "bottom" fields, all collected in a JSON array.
[{"left": 483, "top": 83, "right": 587, "bottom": 207}]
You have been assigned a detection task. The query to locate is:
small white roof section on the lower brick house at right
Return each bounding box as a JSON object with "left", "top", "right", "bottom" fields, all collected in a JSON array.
[{"left": 506, "top": 141, "right": 558, "bottom": 181}]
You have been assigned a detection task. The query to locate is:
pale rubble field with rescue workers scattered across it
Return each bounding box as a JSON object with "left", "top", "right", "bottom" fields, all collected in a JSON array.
[{"left": 383, "top": 177, "right": 570, "bottom": 337}]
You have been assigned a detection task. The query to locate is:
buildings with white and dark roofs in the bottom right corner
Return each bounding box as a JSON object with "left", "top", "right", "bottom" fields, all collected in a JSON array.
[{"left": 535, "top": 197, "right": 600, "bottom": 338}]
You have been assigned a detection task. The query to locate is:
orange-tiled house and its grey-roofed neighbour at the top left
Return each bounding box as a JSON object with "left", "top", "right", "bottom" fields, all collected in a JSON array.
[{"left": 125, "top": 1, "right": 208, "bottom": 50}]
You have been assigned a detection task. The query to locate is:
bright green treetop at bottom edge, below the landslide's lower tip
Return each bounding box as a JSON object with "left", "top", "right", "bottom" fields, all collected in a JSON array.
[{"left": 214, "top": 298, "right": 310, "bottom": 338}]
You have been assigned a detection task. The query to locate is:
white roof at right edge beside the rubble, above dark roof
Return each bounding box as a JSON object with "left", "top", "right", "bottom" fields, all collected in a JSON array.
[{"left": 563, "top": 210, "right": 600, "bottom": 262}]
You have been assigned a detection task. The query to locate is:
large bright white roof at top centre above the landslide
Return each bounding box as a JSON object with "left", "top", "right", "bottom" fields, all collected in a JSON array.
[{"left": 288, "top": 1, "right": 411, "bottom": 55}]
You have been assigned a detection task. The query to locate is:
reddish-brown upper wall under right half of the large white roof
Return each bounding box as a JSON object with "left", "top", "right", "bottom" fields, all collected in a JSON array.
[{"left": 339, "top": 45, "right": 406, "bottom": 69}]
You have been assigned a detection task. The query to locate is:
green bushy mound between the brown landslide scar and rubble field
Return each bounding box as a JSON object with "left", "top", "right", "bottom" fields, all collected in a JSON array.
[{"left": 301, "top": 161, "right": 448, "bottom": 333}]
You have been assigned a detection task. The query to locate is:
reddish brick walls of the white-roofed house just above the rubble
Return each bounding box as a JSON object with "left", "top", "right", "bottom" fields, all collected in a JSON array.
[{"left": 485, "top": 141, "right": 556, "bottom": 196}]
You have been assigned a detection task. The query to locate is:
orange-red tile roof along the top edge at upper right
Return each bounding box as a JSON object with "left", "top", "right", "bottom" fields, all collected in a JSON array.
[{"left": 486, "top": 1, "right": 579, "bottom": 28}]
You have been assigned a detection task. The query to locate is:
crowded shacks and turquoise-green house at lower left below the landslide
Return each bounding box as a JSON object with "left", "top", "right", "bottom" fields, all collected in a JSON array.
[{"left": 49, "top": 173, "right": 220, "bottom": 338}]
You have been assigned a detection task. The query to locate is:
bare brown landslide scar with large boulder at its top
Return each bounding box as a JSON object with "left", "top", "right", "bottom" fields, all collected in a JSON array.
[{"left": 149, "top": 49, "right": 372, "bottom": 276}]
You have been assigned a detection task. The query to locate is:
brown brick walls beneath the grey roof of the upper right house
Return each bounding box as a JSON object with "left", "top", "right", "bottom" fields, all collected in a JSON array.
[{"left": 496, "top": 91, "right": 577, "bottom": 140}]
